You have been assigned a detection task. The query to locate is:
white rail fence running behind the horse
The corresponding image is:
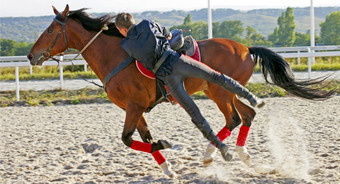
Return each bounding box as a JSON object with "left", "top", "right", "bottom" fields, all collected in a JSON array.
[{"left": 0, "top": 45, "right": 340, "bottom": 100}]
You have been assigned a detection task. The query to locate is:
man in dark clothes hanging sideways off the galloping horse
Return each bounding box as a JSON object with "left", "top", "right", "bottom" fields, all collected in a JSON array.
[{"left": 115, "top": 13, "right": 264, "bottom": 160}]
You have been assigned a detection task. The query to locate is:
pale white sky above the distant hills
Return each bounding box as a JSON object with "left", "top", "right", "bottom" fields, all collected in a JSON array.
[{"left": 0, "top": 0, "right": 340, "bottom": 17}]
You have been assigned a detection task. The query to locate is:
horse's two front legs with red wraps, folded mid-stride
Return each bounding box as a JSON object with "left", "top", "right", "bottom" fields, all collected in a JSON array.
[{"left": 122, "top": 105, "right": 176, "bottom": 178}]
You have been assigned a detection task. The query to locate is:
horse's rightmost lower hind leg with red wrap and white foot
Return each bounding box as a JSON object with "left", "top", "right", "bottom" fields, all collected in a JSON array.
[{"left": 235, "top": 99, "right": 256, "bottom": 167}]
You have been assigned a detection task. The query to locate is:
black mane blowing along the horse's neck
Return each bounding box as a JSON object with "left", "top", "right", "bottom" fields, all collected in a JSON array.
[{"left": 68, "top": 8, "right": 124, "bottom": 38}]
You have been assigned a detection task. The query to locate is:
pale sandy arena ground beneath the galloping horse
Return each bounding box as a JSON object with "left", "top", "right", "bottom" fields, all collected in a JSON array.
[{"left": 0, "top": 96, "right": 340, "bottom": 184}]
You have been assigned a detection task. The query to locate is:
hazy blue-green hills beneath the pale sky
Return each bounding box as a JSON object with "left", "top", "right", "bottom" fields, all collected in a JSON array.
[{"left": 0, "top": 7, "right": 340, "bottom": 43}]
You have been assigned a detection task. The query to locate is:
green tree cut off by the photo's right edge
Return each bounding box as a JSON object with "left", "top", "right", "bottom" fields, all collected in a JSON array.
[{"left": 320, "top": 11, "right": 340, "bottom": 45}]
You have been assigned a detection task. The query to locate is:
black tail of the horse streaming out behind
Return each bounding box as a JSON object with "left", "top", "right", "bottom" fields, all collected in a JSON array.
[{"left": 249, "top": 47, "right": 336, "bottom": 100}]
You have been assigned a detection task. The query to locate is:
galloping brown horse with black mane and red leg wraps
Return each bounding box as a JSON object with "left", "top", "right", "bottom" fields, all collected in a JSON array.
[{"left": 27, "top": 5, "right": 335, "bottom": 176}]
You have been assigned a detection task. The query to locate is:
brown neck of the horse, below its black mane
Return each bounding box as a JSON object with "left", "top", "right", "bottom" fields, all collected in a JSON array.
[{"left": 67, "top": 21, "right": 127, "bottom": 81}]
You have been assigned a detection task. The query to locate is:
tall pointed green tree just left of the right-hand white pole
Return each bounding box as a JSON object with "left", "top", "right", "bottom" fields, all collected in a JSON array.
[{"left": 269, "top": 7, "right": 295, "bottom": 47}]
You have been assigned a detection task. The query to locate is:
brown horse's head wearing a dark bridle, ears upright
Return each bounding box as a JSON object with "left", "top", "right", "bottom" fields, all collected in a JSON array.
[{"left": 27, "top": 5, "right": 69, "bottom": 65}]
